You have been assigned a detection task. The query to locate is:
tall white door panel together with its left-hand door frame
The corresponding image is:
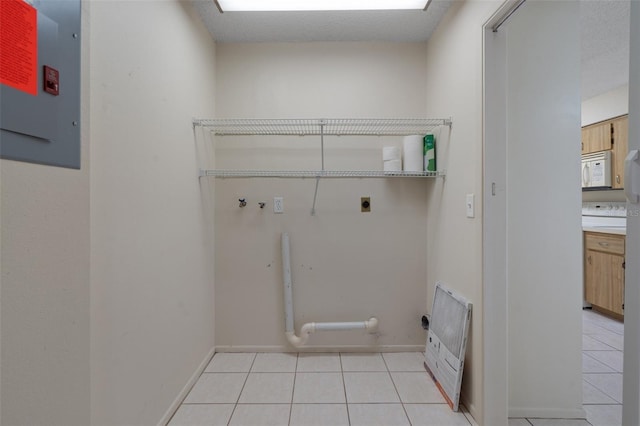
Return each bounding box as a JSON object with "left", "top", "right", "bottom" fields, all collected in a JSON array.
[{"left": 483, "top": 1, "right": 584, "bottom": 424}]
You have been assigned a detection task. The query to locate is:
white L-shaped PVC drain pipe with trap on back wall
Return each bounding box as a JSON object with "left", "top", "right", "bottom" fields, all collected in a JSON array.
[{"left": 282, "top": 232, "right": 378, "bottom": 347}]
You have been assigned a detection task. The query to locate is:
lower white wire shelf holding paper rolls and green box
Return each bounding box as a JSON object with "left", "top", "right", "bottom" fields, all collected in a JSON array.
[{"left": 200, "top": 170, "right": 445, "bottom": 179}]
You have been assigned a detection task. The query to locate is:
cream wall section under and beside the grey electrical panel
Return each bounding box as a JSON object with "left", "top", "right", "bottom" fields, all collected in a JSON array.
[{"left": 0, "top": 4, "right": 90, "bottom": 426}]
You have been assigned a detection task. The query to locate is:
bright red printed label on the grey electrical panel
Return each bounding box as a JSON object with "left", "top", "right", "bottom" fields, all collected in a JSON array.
[{"left": 0, "top": 0, "right": 38, "bottom": 95}]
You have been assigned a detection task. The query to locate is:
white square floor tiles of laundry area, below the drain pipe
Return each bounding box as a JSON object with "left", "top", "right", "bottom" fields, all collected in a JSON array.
[{"left": 169, "top": 352, "right": 475, "bottom": 426}]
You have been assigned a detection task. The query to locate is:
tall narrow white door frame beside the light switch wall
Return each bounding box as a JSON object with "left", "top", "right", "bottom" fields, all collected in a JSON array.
[{"left": 482, "top": 0, "right": 516, "bottom": 425}]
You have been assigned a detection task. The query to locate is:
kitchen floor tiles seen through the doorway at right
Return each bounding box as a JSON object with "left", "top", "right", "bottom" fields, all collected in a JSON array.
[{"left": 509, "top": 310, "right": 624, "bottom": 426}]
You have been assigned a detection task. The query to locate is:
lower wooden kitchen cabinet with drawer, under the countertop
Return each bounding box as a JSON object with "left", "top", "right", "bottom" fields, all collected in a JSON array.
[{"left": 584, "top": 232, "right": 625, "bottom": 319}]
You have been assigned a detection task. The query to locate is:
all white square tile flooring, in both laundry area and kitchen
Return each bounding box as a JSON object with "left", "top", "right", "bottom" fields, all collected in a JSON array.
[{"left": 169, "top": 310, "right": 624, "bottom": 426}]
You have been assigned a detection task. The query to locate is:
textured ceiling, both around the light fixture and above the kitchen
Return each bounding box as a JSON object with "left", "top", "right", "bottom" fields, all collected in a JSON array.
[{"left": 193, "top": 0, "right": 630, "bottom": 99}]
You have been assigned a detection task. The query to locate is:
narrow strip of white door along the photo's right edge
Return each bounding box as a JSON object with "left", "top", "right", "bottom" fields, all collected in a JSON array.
[{"left": 622, "top": 1, "right": 640, "bottom": 425}]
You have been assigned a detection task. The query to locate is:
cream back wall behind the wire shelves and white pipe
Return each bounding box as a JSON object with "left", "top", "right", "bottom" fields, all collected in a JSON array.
[{"left": 215, "top": 43, "right": 433, "bottom": 350}]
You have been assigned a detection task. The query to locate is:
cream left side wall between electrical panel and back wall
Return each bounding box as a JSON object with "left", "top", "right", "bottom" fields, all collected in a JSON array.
[{"left": 89, "top": 1, "right": 215, "bottom": 425}]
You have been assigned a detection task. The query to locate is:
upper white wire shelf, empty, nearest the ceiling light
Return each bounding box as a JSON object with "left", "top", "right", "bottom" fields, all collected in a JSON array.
[{"left": 193, "top": 118, "right": 451, "bottom": 136}]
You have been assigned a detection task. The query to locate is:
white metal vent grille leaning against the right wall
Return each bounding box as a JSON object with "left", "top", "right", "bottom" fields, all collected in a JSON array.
[{"left": 425, "top": 282, "right": 472, "bottom": 411}]
